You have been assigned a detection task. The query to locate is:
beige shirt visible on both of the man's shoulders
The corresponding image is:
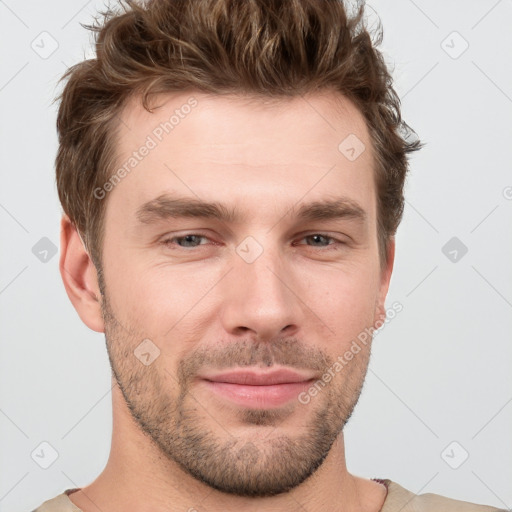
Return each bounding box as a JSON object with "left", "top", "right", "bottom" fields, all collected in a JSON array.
[{"left": 32, "top": 478, "right": 506, "bottom": 512}]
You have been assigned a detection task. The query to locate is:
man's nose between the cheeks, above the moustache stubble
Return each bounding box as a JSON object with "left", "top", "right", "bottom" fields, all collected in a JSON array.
[{"left": 220, "top": 241, "right": 305, "bottom": 341}]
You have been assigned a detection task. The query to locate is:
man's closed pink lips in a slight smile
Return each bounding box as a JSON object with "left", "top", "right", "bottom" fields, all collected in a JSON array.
[{"left": 200, "top": 368, "right": 315, "bottom": 409}]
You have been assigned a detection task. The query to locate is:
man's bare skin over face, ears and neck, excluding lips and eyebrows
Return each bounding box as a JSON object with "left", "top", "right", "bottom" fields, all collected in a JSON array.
[{"left": 60, "top": 92, "right": 394, "bottom": 512}]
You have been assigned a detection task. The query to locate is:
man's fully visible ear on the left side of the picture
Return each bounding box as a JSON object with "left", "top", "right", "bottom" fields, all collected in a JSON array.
[{"left": 59, "top": 215, "right": 104, "bottom": 332}]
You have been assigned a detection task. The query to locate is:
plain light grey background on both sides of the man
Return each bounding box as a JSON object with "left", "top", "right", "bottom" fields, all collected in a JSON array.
[{"left": 0, "top": 0, "right": 512, "bottom": 512}]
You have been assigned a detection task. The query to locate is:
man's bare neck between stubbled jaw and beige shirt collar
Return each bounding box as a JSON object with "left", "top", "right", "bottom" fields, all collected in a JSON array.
[{"left": 69, "top": 385, "right": 386, "bottom": 512}]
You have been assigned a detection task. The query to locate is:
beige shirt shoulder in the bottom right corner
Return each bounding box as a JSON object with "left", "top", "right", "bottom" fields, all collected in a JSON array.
[{"left": 378, "top": 479, "right": 505, "bottom": 512}]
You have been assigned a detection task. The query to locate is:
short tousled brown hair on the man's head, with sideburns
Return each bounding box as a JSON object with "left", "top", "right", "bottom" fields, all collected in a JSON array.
[{"left": 56, "top": 0, "right": 422, "bottom": 272}]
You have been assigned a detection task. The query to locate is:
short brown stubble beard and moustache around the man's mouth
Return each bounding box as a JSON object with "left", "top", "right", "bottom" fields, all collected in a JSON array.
[{"left": 102, "top": 294, "right": 369, "bottom": 497}]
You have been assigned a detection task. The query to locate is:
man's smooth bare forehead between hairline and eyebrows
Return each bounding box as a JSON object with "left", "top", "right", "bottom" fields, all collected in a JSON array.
[{"left": 109, "top": 91, "right": 374, "bottom": 224}]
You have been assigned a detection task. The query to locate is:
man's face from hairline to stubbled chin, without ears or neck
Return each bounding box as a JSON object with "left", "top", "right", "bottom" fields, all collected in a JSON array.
[{"left": 102, "top": 93, "right": 389, "bottom": 496}]
